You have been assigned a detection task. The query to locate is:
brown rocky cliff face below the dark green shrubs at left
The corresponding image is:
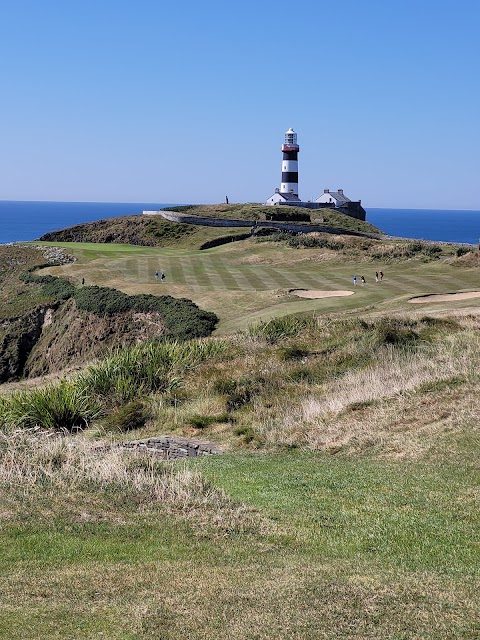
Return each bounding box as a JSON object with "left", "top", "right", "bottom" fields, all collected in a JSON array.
[{"left": 0, "top": 299, "right": 169, "bottom": 382}]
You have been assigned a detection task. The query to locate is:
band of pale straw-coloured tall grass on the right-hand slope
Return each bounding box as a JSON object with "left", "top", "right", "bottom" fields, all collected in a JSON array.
[{"left": 258, "top": 331, "right": 480, "bottom": 446}]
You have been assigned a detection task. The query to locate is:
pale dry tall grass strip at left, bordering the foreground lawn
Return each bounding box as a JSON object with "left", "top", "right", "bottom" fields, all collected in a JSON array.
[{"left": 0, "top": 430, "right": 270, "bottom": 537}]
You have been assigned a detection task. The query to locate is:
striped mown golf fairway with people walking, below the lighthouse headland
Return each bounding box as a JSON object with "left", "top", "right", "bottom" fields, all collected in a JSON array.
[{"left": 35, "top": 241, "right": 479, "bottom": 333}]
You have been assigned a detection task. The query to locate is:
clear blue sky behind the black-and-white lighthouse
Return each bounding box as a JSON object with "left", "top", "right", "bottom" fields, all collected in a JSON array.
[{"left": 0, "top": 0, "right": 480, "bottom": 209}]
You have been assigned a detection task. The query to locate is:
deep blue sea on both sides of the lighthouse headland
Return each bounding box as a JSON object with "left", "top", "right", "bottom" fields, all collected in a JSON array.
[{"left": 0, "top": 200, "right": 480, "bottom": 244}]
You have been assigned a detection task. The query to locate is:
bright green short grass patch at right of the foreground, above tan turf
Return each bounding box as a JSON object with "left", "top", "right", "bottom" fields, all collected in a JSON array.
[{"left": 197, "top": 452, "right": 480, "bottom": 577}]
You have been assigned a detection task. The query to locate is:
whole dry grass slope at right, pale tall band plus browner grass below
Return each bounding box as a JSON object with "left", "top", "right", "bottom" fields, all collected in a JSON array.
[{"left": 256, "top": 331, "right": 480, "bottom": 457}]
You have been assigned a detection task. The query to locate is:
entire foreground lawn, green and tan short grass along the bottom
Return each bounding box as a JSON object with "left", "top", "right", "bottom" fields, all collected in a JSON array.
[{"left": 0, "top": 451, "right": 480, "bottom": 640}]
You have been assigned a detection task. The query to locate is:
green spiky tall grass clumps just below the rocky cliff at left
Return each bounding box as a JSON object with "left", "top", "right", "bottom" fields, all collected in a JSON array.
[{"left": 0, "top": 340, "right": 225, "bottom": 431}]
